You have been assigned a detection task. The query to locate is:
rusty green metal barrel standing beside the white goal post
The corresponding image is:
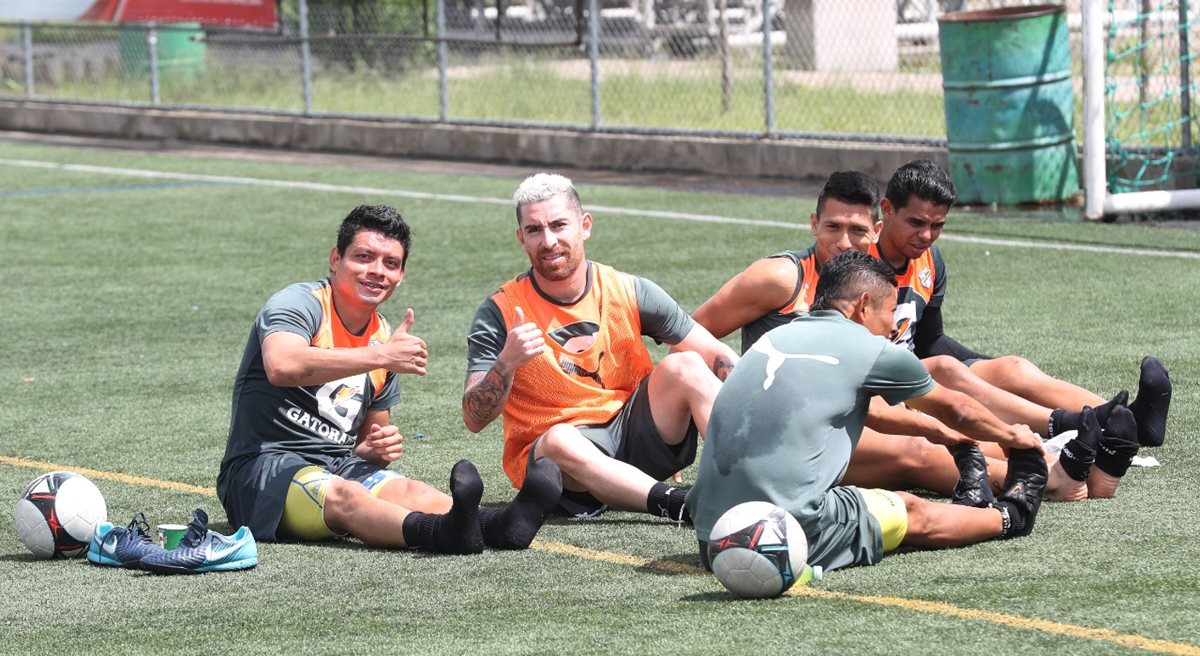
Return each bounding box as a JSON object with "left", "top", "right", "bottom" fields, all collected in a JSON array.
[{"left": 938, "top": 5, "right": 1079, "bottom": 205}]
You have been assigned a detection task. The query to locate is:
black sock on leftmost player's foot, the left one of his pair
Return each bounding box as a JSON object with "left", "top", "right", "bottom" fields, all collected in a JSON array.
[{"left": 402, "top": 461, "right": 484, "bottom": 554}]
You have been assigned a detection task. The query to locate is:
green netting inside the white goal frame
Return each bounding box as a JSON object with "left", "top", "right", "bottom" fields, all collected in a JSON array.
[{"left": 1105, "top": 0, "right": 1200, "bottom": 193}]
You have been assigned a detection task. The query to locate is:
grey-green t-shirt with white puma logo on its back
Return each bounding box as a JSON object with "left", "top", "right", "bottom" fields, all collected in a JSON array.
[{"left": 688, "top": 311, "right": 934, "bottom": 541}]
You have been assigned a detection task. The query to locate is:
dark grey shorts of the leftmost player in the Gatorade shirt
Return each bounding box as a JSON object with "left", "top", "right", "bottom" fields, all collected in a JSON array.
[{"left": 217, "top": 451, "right": 384, "bottom": 541}]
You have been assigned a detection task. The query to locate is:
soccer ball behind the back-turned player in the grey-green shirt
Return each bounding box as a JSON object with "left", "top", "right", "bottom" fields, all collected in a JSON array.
[{"left": 708, "top": 501, "right": 809, "bottom": 598}]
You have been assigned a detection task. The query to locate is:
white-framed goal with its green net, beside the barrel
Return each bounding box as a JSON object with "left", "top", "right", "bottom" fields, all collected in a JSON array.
[{"left": 1082, "top": 0, "right": 1200, "bottom": 218}]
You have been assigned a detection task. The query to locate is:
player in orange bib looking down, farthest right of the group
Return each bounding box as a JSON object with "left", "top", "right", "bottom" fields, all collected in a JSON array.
[{"left": 871, "top": 160, "right": 1171, "bottom": 458}]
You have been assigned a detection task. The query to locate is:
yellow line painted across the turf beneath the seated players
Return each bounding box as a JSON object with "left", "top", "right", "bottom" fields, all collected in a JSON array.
[{"left": 0, "top": 456, "right": 1200, "bottom": 656}]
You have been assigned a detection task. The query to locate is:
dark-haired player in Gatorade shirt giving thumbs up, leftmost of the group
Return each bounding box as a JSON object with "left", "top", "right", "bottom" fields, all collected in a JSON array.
[{"left": 217, "top": 205, "right": 562, "bottom": 554}]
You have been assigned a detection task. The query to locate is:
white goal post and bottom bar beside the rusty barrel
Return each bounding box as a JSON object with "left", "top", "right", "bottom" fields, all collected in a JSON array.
[{"left": 1081, "top": 0, "right": 1200, "bottom": 219}]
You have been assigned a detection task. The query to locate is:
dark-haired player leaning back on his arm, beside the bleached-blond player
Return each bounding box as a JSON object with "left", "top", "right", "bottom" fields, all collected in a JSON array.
[{"left": 694, "top": 171, "right": 1132, "bottom": 500}]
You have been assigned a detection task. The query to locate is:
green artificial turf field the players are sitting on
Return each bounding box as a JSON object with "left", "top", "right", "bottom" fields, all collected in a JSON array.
[{"left": 0, "top": 136, "right": 1200, "bottom": 654}]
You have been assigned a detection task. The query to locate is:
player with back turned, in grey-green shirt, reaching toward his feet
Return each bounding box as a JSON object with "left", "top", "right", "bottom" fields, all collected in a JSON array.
[{"left": 688, "top": 251, "right": 1046, "bottom": 570}]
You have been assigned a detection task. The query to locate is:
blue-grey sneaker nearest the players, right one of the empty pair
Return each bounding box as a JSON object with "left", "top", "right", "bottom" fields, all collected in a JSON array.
[{"left": 142, "top": 508, "right": 258, "bottom": 574}]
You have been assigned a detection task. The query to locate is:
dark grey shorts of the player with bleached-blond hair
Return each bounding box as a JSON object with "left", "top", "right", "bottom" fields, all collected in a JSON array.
[{"left": 529, "top": 375, "right": 700, "bottom": 517}]
